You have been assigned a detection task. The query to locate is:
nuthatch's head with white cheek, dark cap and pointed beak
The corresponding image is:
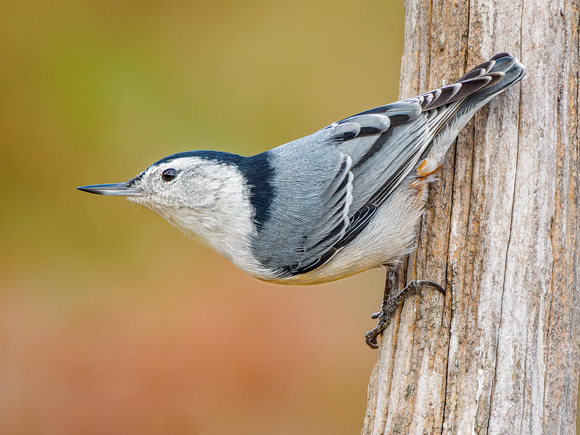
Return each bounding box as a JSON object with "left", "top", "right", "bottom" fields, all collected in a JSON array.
[{"left": 78, "top": 151, "right": 251, "bottom": 244}]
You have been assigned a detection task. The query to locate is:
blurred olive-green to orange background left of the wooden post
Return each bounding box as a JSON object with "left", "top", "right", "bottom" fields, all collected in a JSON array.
[{"left": 0, "top": 0, "right": 403, "bottom": 435}]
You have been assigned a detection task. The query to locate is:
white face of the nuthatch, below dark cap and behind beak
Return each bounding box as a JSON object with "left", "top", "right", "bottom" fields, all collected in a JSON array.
[{"left": 128, "top": 157, "right": 253, "bottom": 258}]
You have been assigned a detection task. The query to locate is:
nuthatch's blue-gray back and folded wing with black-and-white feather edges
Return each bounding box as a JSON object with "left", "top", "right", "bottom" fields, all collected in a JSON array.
[{"left": 254, "top": 53, "right": 511, "bottom": 277}]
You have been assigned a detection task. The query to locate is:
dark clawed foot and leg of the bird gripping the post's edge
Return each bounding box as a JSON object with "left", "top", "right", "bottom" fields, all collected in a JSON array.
[{"left": 365, "top": 268, "right": 445, "bottom": 349}]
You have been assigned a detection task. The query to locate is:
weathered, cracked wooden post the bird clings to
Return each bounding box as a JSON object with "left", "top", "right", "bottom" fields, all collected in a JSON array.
[{"left": 363, "top": 0, "right": 580, "bottom": 434}]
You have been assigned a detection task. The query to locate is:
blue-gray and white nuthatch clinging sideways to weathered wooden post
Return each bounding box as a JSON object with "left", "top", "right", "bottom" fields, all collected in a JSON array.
[{"left": 78, "top": 53, "right": 526, "bottom": 347}]
